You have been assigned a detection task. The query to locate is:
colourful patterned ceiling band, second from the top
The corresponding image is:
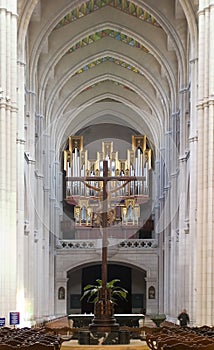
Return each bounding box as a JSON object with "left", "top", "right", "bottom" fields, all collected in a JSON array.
[{"left": 68, "top": 29, "right": 149, "bottom": 53}]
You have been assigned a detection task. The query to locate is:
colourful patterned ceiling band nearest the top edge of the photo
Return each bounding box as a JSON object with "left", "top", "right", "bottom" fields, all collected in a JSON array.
[{"left": 55, "top": 0, "right": 160, "bottom": 29}]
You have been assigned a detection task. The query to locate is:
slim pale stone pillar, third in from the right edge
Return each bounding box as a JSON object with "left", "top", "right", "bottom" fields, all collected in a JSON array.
[{"left": 174, "top": 86, "right": 190, "bottom": 315}]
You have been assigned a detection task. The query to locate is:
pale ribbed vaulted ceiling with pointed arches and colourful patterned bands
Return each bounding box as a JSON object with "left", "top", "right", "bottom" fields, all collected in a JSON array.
[{"left": 18, "top": 0, "right": 197, "bottom": 153}]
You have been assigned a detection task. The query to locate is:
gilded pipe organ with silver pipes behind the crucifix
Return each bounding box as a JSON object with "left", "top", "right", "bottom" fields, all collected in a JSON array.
[{"left": 64, "top": 135, "right": 151, "bottom": 227}]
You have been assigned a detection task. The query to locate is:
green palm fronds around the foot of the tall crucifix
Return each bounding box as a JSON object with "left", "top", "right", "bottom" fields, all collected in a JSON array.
[{"left": 80, "top": 279, "right": 128, "bottom": 304}]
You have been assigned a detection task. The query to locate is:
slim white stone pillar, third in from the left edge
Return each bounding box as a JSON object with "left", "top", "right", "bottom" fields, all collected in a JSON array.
[{"left": 24, "top": 90, "right": 38, "bottom": 319}]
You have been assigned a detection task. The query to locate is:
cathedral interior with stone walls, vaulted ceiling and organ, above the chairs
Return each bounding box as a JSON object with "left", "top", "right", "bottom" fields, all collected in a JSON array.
[{"left": 0, "top": 0, "right": 214, "bottom": 325}]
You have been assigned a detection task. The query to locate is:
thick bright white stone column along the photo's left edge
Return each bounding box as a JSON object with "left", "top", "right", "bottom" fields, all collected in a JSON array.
[{"left": 0, "top": 0, "right": 17, "bottom": 322}]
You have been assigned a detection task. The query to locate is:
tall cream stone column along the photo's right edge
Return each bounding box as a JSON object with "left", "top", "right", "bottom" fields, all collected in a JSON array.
[{"left": 196, "top": 0, "right": 214, "bottom": 325}]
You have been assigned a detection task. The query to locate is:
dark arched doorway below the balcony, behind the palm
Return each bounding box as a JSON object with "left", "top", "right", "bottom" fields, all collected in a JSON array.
[{"left": 67, "top": 263, "right": 146, "bottom": 314}]
